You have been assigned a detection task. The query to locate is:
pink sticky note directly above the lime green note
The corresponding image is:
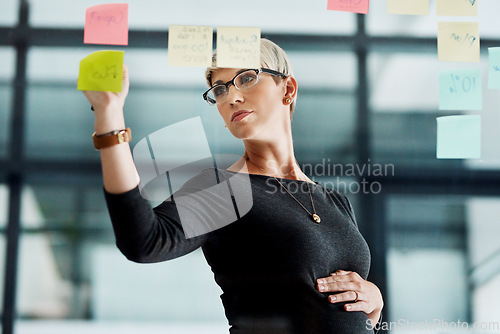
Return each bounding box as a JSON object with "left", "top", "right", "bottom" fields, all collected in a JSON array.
[{"left": 83, "top": 3, "right": 128, "bottom": 45}]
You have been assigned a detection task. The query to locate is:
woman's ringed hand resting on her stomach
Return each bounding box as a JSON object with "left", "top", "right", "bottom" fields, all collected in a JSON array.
[{"left": 317, "top": 270, "right": 384, "bottom": 327}]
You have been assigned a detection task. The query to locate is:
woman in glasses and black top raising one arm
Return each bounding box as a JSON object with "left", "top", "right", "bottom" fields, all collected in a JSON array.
[{"left": 84, "top": 39, "right": 383, "bottom": 334}]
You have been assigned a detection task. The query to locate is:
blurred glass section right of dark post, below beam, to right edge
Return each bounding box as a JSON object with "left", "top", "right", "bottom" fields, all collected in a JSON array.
[{"left": 387, "top": 194, "right": 500, "bottom": 332}]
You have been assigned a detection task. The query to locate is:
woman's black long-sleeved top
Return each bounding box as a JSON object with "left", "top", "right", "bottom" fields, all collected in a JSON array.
[{"left": 105, "top": 169, "right": 373, "bottom": 334}]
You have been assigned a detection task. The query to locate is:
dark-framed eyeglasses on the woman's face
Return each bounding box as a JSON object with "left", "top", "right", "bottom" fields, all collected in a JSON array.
[{"left": 203, "top": 68, "right": 286, "bottom": 106}]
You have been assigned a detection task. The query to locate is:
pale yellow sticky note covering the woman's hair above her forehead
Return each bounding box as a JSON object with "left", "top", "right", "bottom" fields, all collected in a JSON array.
[{"left": 217, "top": 27, "right": 260, "bottom": 68}]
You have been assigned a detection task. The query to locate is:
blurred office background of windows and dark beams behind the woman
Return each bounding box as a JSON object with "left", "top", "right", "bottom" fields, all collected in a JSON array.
[{"left": 0, "top": 0, "right": 500, "bottom": 334}]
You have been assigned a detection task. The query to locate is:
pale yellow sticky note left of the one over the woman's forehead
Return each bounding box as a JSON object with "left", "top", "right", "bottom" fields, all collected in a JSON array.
[{"left": 168, "top": 25, "right": 213, "bottom": 67}]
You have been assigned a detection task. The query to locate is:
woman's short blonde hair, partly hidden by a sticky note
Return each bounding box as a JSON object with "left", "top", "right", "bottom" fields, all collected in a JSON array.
[{"left": 205, "top": 38, "right": 295, "bottom": 120}]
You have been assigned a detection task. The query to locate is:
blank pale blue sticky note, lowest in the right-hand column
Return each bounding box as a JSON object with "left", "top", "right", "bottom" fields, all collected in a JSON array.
[{"left": 436, "top": 115, "right": 481, "bottom": 159}]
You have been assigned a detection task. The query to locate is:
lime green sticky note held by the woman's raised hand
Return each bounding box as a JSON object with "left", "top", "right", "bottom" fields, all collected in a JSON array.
[{"left": 78, "top": 51, "right": 124, "bottom": 93}]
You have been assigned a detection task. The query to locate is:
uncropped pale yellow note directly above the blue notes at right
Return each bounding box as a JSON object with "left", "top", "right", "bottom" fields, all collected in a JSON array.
[{"left": 438, "top": 22, "right": 479, "bottom": 62}]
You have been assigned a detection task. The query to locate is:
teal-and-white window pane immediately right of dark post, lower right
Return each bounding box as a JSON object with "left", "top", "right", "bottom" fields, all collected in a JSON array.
[{"left": 387, "top": 195, "right": 470, "bottom": 323}]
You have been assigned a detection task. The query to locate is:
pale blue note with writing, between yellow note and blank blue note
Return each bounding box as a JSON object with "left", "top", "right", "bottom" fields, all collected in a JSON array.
[{"left": 439, "top": 68, "right": 483, "bottom": 110}]
